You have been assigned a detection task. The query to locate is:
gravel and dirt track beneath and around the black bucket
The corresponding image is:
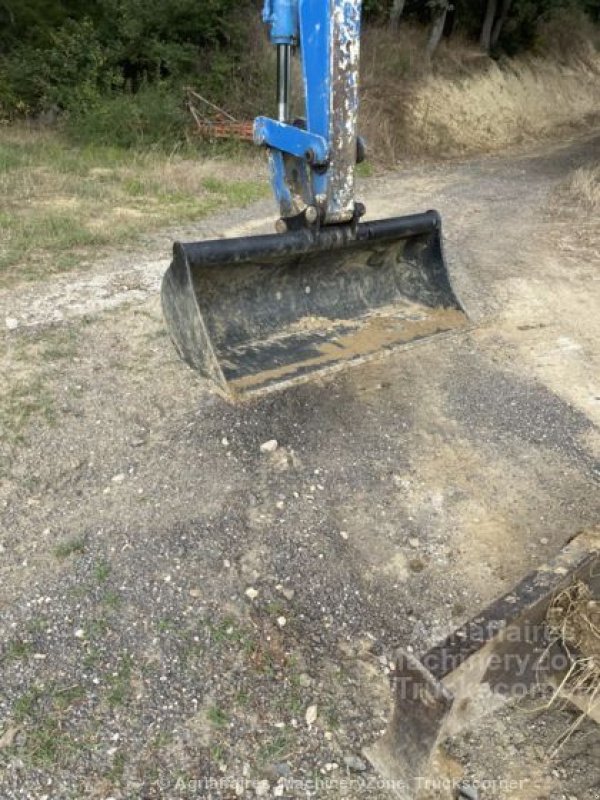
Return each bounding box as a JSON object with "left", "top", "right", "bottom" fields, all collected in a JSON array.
[{"left": 0, "top": 136, "right": 600, "bottom": 800}]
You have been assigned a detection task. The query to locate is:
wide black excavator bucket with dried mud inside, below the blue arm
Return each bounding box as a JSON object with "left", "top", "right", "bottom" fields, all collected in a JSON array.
[{"left": 162, "top": 211, "right": 467, "bottom": 399}]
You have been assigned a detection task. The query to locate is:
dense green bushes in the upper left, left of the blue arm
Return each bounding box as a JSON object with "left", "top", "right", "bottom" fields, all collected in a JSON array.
[{"left": 0, "top": 0, "right": 259, "bottom": 118}]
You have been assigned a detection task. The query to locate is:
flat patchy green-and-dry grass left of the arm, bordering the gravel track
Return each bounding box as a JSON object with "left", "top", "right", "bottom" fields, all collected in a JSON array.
[{"left": 0, "top": 126, "right": 268, "bottom": 287}]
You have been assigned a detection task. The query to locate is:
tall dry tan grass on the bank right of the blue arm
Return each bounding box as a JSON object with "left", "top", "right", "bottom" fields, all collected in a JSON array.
[{"left": 362, "top": 28, "right": 600, "bottom": 163}]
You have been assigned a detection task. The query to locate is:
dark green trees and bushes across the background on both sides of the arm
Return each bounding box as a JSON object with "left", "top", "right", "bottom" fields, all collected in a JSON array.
[{"left": 0, "top": 0, "right": 600, "bottom": 144}]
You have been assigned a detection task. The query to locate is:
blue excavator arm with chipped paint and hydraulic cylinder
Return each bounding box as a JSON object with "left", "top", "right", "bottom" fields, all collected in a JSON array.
[{"left": 254, "top": 0, "right": 363, "bottom": 232}]
